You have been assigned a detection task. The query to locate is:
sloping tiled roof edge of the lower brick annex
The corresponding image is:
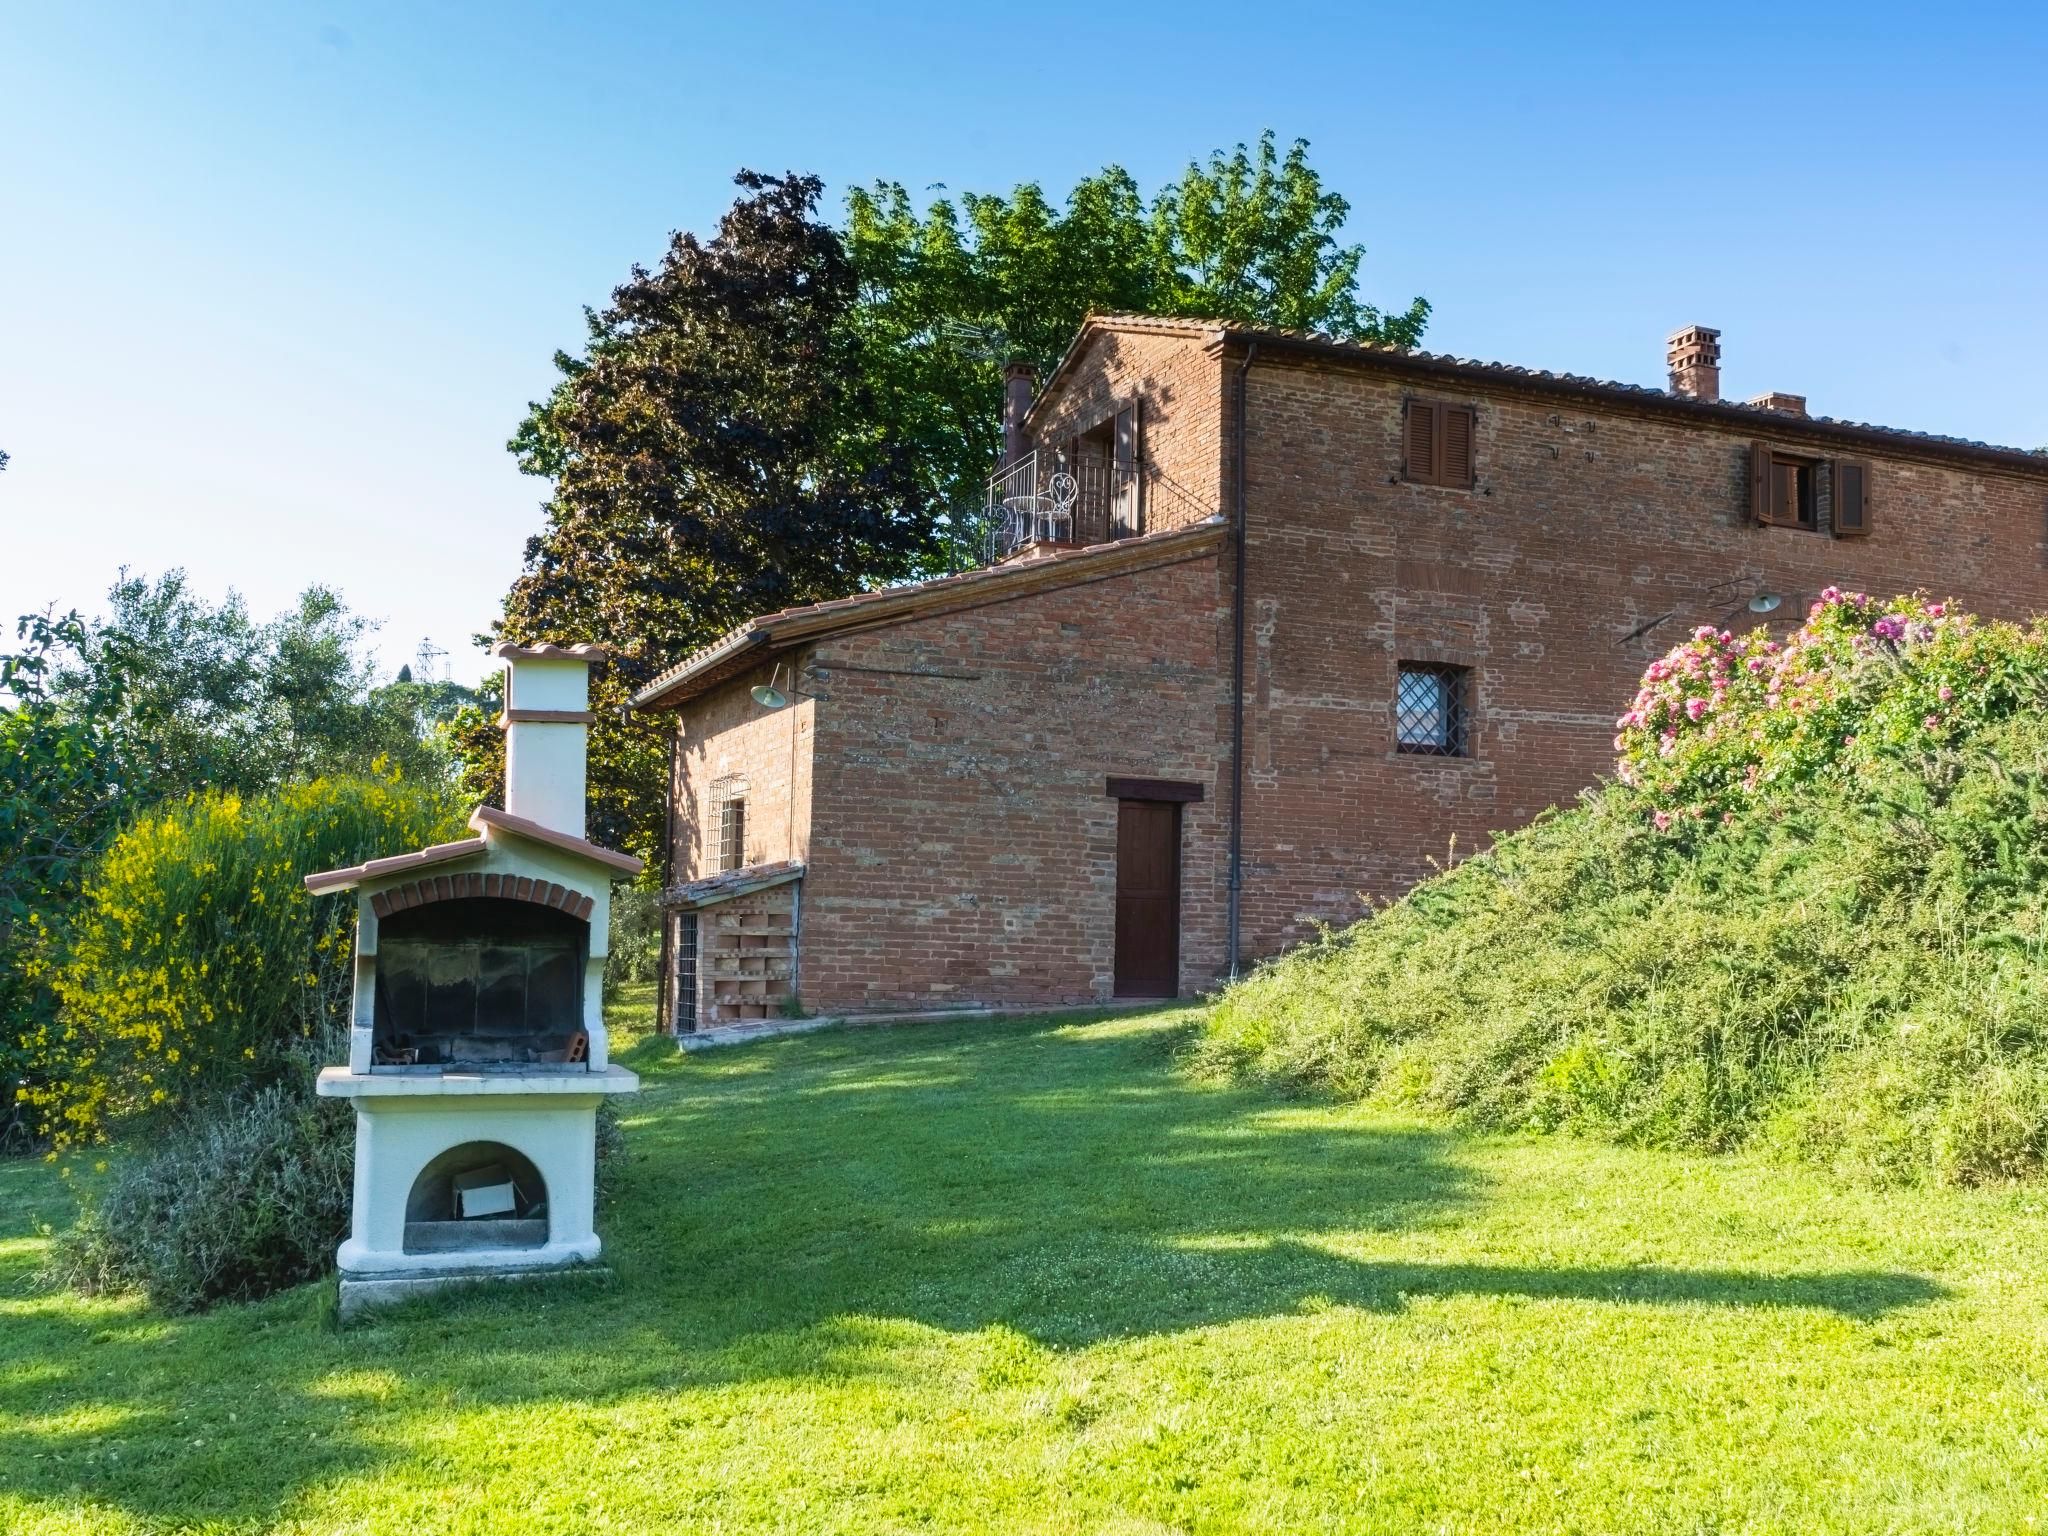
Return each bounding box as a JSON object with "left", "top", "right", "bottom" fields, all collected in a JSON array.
[{"left": 633, "top": 518, "right": 1229, "bottom": 709}]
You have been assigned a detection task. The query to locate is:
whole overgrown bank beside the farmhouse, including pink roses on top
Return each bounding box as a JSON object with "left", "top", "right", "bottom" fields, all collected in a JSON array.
[{"left": 1202, "top": 590, "right": 2048, "bottom": 1184}]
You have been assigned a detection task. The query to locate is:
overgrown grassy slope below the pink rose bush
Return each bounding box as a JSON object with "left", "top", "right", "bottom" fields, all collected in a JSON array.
[{"left": 1204, "top": 711, "right": 2048, "bottom": 1184}]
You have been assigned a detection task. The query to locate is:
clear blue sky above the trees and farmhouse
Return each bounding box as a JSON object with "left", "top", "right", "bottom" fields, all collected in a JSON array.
[{"left": 0, "top": 0, "right": 2048, "bottom": 676}]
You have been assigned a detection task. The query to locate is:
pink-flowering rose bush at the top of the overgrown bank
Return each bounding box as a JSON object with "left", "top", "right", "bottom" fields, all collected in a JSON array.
[{"left": 1614, "top": 588, "right": 2048, "bottom": 831}]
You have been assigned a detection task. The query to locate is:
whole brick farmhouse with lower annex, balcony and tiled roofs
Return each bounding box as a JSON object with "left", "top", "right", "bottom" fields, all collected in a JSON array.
[{"left": 635, "top": 317, "right": 2048, "bottom": 1032}]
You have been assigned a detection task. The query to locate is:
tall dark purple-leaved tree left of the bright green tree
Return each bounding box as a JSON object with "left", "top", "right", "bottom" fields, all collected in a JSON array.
[{"left": 487, "top": 172, "right": 934, "bottom": 856}]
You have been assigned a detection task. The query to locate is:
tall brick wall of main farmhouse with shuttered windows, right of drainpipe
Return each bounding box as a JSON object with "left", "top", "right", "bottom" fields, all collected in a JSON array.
[{"left": 1243, "top": 352, "right": 2048, "bottom": 952}]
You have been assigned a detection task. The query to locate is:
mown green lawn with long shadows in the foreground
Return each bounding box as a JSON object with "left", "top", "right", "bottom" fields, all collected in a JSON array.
[{"left": 0, "top": 1010, "right": 2048, "bottom": 1536}]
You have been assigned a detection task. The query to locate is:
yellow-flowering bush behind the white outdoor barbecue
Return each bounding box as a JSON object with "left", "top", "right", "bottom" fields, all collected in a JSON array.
[{"left": 20, "top": 776, "right": 459, "bottom": 1147}]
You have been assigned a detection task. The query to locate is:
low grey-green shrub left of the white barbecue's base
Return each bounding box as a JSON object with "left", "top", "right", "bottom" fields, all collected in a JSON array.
[{"left": 47, "top": 1083, "right": 354, "bottom": 1313}]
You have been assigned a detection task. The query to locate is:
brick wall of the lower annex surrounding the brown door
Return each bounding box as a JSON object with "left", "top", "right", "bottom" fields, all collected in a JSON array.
[{"left": 801, "top": 553, "right": 1229, "bottom": 1012}]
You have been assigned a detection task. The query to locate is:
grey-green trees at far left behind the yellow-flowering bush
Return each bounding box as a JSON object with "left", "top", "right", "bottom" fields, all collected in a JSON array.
[{"left": 0, "top": 571, "right": 473, "bottom": 1139}]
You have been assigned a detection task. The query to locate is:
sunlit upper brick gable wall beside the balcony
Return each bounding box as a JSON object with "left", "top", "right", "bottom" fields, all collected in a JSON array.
[{"left": 1032, "top": 332, "right": 1225, "bottom": 532}]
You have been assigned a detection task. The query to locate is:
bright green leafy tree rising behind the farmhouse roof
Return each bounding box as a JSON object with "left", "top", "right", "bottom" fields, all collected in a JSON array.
[{"left": 848, "top": 131, "right": 1430, "bottom": 557}]
